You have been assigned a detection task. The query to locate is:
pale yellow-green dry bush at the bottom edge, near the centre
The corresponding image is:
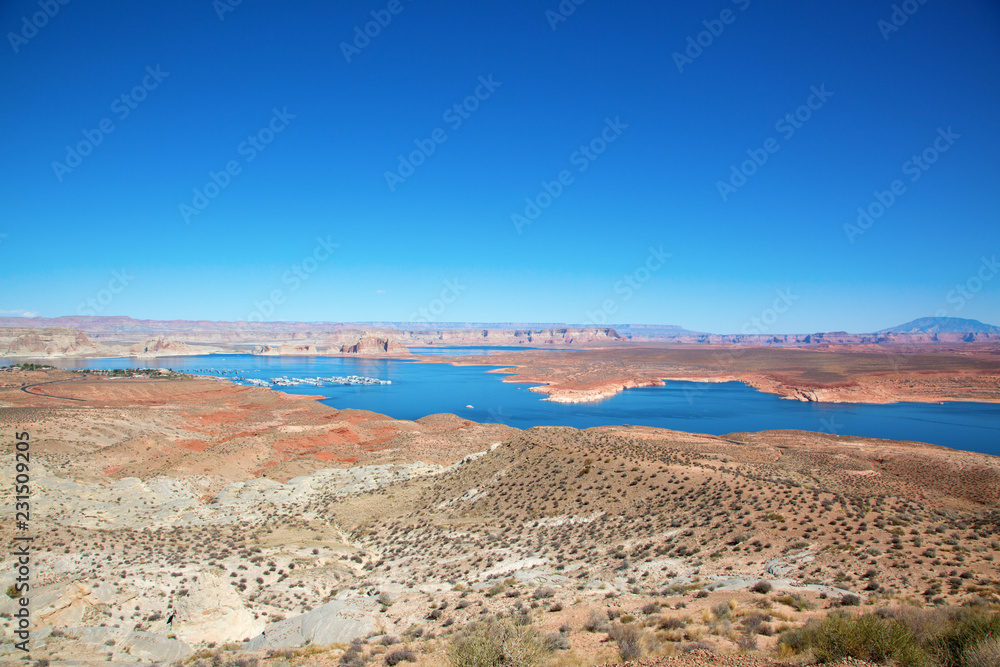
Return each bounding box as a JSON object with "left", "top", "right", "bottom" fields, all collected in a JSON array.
[{"left": 448, "top": 618, "right": 548, "bottom": 667}]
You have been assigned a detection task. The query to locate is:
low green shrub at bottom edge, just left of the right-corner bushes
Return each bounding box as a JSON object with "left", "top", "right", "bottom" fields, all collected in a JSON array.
[{"left": 779, "top": 611, "right": 928, "bottom": 667}]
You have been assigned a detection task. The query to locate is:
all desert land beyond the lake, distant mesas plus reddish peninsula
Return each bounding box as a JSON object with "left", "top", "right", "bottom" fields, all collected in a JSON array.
[{"left": 0, "top": 317, "right": 1000, "bottom": 410}]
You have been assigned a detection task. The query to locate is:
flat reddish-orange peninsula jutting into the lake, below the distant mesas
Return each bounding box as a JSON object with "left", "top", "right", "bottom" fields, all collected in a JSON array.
[{"left": 448, "top": 343, "right": 1000, "bottom": 403}]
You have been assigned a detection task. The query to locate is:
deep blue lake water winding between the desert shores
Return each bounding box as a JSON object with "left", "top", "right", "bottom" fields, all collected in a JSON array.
[{"left": 15, "top": 348, "right": 1000, "bottom": 455}]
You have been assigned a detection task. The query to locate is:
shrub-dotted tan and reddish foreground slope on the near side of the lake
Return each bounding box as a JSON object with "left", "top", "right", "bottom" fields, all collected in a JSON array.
[{"left": 0, "top": 370, "right": 1000, "bottom": 666}]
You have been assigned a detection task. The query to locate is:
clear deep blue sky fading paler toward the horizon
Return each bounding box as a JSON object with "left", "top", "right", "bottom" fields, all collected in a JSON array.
[{"left": 0, "top": 0, "right": 1000, "bottom": 332}]
